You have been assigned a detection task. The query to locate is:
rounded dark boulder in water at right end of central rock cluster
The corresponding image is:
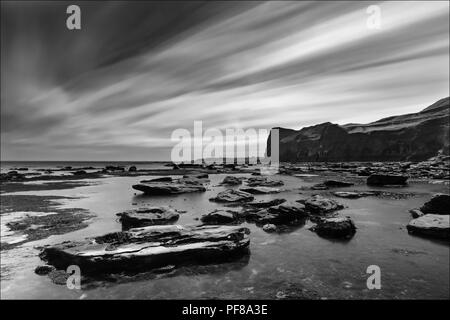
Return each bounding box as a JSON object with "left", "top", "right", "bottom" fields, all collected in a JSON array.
[{"left": 312, "top": 217, "right": 356, "bottom": 239}]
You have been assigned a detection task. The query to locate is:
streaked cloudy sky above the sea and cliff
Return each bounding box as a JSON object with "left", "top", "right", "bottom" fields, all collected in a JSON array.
[{"left": 0, "top": 1, "right": 450, "bottom": 161}]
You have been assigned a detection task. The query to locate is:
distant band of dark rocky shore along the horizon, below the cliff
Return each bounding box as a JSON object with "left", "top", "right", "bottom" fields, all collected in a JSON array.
[{"left": 0, "top": 155, "right": 450, "bottom": 188}]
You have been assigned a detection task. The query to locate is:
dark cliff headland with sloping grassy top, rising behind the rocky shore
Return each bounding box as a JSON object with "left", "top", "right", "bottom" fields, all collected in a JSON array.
[{"left": 267, "top": 98, "right": 450, "bottom": 162}]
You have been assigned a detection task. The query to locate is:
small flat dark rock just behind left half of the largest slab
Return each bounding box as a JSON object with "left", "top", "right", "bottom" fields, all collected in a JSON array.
[{"left": 117, "top": 207, "right": 180, "bottom": 229}]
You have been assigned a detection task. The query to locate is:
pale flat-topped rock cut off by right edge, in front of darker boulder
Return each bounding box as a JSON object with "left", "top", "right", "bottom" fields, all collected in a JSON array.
[{"left": 406, "top": 214, "right": 450, "bottom": 239}]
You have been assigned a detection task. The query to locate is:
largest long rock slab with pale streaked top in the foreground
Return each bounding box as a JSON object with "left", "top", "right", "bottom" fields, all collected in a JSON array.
[{"left": 39, "top": 225, "right": 250, "bottom": 274}]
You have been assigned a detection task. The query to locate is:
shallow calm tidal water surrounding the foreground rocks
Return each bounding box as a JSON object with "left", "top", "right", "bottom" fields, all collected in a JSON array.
[{"left": 1, "top": 169, "right": 450, "bottom": 299}]
